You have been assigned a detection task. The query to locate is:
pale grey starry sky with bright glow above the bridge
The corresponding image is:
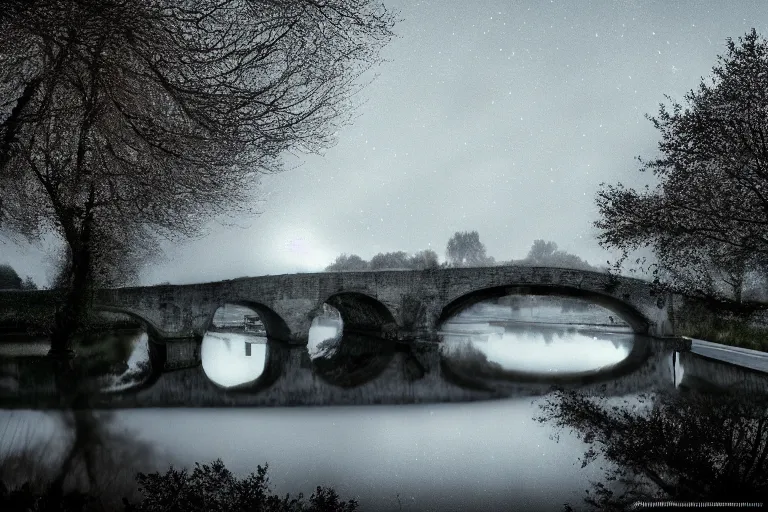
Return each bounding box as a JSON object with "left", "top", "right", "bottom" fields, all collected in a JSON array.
[{"left": 0, "top": 0, "right": 768, "bottom": 284}]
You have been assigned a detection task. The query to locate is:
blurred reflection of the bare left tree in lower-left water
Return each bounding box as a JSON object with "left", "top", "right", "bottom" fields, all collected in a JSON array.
[{"left": 0, "top": 409, "right": 168, "bottom": 510}]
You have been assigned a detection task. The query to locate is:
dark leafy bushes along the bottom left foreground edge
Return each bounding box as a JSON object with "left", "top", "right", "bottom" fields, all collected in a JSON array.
[{"left": 0, "top": 460, "right": 358, "bottom": 512}]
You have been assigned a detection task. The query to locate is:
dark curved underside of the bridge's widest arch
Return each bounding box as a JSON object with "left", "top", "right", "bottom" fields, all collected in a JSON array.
[{"left": 437, "top": 284, "right": 651, "bottom": 334}]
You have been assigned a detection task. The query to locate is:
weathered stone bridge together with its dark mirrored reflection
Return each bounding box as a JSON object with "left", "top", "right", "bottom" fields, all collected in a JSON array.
[{"left": 0, "top": 267, "right": 690, "bottom": 408}]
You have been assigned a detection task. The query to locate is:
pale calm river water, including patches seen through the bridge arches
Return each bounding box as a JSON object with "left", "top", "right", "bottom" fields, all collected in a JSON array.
[{"left": 0, "top": 298, "right": 764, "bottom": 511}]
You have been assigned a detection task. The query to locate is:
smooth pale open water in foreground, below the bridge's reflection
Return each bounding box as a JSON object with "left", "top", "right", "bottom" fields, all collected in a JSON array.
[{"left": 0, "top": 399, "right": 598, "bottom": 512}]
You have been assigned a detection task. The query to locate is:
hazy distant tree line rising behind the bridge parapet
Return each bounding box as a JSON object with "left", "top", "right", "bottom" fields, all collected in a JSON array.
[{"left": 325, "top": 231, "right": 607, "bottom": 272}]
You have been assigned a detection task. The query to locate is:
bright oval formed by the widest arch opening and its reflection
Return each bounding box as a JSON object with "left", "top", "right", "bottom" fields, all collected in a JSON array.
[{"left": 439, "top": 295, "right": 641, "bottom": 381}]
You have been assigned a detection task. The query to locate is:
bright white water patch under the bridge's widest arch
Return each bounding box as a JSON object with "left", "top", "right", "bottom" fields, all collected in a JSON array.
[{"left": 442, "top": 322, "right": 634, "bottom": 373}]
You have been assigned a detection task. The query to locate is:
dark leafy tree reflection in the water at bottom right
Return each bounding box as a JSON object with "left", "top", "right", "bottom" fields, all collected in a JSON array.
[{"left": 535, "top": 389, "right": 768, "bottom": 511}]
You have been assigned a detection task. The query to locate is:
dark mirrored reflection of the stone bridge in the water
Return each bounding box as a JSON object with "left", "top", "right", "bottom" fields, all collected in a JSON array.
[{"left": 0, "top": 334, "right": 690, "bottom": 409}]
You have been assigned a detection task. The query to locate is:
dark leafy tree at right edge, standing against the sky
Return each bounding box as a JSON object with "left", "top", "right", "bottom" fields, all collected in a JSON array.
[{"left": 595, "top": 29, "right": 768, "bottom": 301}]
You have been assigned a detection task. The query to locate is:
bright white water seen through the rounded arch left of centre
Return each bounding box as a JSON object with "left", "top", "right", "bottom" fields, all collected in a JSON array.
[{"left": 200, "top": 332, "right": 267, "bottom": 387}]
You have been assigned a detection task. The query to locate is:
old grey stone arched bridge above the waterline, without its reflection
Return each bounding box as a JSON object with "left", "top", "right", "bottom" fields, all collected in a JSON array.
[{"left": 0, "top": 266, "right": 674, "bottom": 343}]
